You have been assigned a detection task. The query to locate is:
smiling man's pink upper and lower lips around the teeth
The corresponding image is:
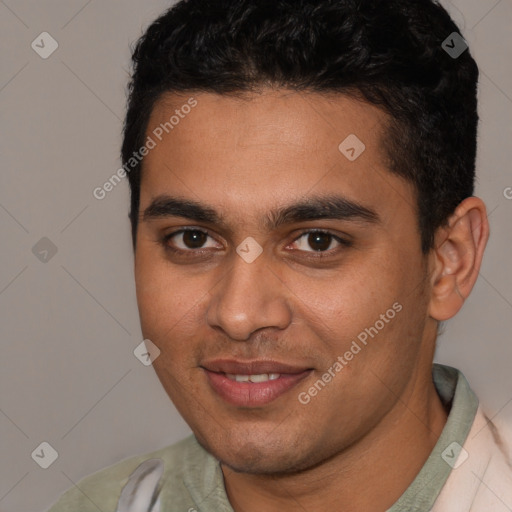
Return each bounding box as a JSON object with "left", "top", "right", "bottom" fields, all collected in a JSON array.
[{"left": 202, "top": 359, "right": 312, "bottom": 407}]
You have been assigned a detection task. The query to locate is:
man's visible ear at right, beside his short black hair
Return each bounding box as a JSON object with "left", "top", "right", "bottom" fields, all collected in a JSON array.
[{"left": 429, "top": 197, "right": 489, "bottom": 322}]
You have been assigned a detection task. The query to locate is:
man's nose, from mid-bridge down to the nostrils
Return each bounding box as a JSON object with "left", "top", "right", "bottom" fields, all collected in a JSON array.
[{"left": 207, "top": 254, "right": 292, "bottom": 341}]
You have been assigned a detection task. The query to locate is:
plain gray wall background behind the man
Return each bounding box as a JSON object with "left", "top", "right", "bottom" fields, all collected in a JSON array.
[{"left": 0, "top": 0, "right": 512, "bottom": 512}]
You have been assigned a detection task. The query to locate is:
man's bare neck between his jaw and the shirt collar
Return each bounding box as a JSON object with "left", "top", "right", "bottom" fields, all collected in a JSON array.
[{"left": 221, "top": 364, "right": 447, "bottom": 512}]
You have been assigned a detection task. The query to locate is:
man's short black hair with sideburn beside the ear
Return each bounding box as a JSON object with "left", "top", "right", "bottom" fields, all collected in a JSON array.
[{"left": 121, "top": 0, "right": 478, "bottom": 253}]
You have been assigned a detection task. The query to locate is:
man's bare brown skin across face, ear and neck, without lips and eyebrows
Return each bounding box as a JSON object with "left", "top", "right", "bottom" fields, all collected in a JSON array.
[{"left": 135, "top": 90, "right": 488, "bottom": 512}]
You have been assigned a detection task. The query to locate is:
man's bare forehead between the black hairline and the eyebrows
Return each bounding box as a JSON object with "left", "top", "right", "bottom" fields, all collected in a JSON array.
[{"left": 141, "top": 90, "right": 413, "bottom": 226}]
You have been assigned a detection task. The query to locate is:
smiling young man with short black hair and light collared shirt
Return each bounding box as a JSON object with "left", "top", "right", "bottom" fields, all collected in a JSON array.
[{"left": 51, "top": 0, "right": 512, "bottom": 512}]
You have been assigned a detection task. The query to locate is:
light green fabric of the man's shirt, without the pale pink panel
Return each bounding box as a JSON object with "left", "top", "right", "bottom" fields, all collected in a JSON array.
[{"left": 49, "top": 364, "right": 478, "bottom": 512}]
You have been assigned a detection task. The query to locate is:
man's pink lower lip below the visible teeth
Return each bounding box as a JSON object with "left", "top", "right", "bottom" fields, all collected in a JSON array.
[{"left": 205, "top": 370, "right": 311, "bottom": 407}]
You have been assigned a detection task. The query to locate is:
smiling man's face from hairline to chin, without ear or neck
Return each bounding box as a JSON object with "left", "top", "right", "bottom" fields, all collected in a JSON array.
[{"left": 135, "top": 91, "right": 435, "bottom": 473}]
